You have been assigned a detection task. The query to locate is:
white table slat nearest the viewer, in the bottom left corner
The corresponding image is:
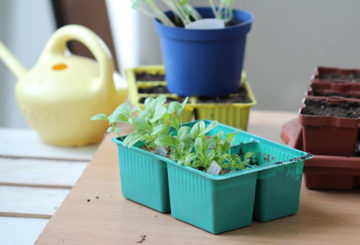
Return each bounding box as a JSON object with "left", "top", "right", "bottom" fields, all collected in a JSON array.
[{"left": 0, "top": 217, "right": 48, "bottom": 245}]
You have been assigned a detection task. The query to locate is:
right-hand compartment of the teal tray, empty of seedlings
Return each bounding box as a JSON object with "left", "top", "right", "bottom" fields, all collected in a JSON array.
[{"left": 219, "top": 121, "right": 311, "bottom": 222}]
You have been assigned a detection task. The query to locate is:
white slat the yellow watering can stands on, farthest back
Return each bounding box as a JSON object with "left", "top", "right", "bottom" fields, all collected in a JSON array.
[{"left": 0, "top": 128, "right": 97, "bottom": 161}]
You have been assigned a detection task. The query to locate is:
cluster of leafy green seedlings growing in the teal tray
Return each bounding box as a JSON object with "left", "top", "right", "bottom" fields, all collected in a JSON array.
[{"left": 91, "top": 96, "right": 254, "bottom": 173}]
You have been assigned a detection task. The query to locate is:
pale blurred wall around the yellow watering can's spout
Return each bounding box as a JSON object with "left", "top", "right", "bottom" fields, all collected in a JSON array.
[{"left": 0, "top": 0, "right": 55, "bottom": 127}]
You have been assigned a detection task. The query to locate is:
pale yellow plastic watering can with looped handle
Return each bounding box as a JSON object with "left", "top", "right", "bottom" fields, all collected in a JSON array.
[{"left": 0, "top": 25, "right": 127, "bottom": 146}]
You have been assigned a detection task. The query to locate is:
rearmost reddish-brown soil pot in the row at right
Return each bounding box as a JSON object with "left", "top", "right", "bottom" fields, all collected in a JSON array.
[{"left": 311, "top": 67, "right": 360, "bottom": 90}]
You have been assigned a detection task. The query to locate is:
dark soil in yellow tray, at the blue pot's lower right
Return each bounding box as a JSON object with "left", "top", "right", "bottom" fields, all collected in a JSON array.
[{"left": 197, "top": 86, "right": 251, "bottom": 104}]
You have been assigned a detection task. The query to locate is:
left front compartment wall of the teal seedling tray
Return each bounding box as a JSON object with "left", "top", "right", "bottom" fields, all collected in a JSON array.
[{"left": 113, "top": 137, "right": 170, "bottom": 213}]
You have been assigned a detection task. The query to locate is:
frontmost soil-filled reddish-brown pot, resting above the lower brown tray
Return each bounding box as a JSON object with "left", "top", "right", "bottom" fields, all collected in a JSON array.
[{"left": 299, "top": 97, "right": 360, "bottom": 156}]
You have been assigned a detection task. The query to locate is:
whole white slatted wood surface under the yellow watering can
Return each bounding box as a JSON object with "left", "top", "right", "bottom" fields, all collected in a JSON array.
[{"left": 0, "top": 128, "right": 97, "bottom": 245}]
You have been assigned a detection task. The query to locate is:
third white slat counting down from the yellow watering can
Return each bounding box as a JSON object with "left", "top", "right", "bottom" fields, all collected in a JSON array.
[{"left": 0, "top": 186, "right": 70, "bottom": 217}]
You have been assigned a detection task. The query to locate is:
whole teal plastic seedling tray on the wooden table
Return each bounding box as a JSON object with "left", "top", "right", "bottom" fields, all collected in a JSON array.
[{"left": 113, "top": 120, "right": 309, "bottom": 234}]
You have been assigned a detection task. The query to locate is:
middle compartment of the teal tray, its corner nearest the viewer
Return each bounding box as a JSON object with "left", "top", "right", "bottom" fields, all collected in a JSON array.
[{"left": 167, "top": 160, "right": 257, "bottom": 234}]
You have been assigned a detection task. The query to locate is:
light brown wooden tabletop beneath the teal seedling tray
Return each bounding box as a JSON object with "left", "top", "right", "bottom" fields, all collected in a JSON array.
[{"left": 36, "top": 111, "right": 360, "bottom": 244}]
